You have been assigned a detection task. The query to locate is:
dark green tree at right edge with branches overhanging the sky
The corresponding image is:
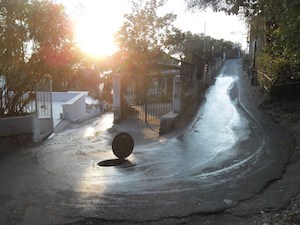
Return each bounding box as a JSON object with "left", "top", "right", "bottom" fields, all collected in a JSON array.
[{"left": 186, "top": 0, "right": 300, "bottom": 82}]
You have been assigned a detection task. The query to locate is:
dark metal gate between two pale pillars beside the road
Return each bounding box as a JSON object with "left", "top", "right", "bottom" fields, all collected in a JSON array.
[{"left": 121, "top": 68, "right": 178, "bottom": 125}]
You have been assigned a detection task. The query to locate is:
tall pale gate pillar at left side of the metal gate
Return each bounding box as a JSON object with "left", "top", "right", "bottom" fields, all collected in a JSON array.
[{"left": 113, "top": 74, "right": 121, "bottom": 122}]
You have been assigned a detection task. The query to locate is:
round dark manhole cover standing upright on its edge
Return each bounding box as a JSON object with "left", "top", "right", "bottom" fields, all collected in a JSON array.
[{"left": 112, "top": 132, "right": 134, "bottom": 159}]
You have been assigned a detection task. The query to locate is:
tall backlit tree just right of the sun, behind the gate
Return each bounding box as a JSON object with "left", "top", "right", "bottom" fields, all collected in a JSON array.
[{"left": 117, "top": 0, "right": 178, "bottom": 73}]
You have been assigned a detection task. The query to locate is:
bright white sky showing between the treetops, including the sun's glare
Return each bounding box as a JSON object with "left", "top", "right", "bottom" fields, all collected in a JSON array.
[{"left": 56, "top": 0, "right": 247, "bottom": 56}]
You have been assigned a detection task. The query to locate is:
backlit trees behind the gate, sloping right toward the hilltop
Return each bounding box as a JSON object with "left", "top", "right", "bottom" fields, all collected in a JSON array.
[{"left": 114, "top": 0, "right": 236, "bottom": 69}]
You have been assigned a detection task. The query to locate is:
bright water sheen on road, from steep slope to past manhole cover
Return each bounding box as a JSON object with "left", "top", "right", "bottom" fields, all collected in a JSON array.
[{"left": 35, "top": 61, "right": 253, "bottom": 193}]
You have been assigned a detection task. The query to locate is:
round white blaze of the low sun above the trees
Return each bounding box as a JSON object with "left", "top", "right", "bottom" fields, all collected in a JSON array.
[{"left": 75, "top": 0, "right": 122, "bottom": 57}]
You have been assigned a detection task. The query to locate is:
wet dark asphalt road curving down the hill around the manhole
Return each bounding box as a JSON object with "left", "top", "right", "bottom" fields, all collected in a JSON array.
[{"left": 0, "top": 60, "right": 294, "bottom": 225}]
